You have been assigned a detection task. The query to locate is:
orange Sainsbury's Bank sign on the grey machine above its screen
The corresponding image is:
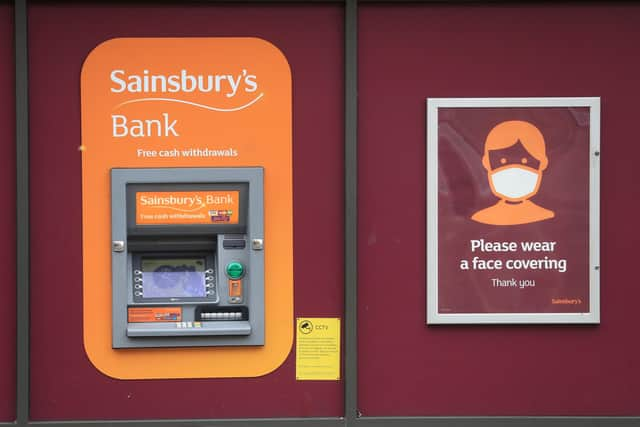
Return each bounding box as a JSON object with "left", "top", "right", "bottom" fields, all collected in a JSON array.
[{"left": 136, "top": 191, "right": 240, "bottom": 225}]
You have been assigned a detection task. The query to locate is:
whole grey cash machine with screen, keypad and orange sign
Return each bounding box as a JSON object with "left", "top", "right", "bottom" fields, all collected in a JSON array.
[{"left": 111, "top": 168, "right": 264, "bottom": 348}]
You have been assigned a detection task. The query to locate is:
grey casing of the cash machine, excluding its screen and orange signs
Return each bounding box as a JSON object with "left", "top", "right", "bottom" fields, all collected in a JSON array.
[{"left": 110, "top": 167, "right": 264, "bottom": 348}]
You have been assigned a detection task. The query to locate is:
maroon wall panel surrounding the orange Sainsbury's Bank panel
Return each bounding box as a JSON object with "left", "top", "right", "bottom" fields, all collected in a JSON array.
[{"left": 29, "top": 3, "right": 344, "bottom": 420}]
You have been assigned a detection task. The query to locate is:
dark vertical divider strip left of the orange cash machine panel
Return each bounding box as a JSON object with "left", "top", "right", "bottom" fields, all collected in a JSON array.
[{"left": 14, "top": 0, "right": 29, "bottom": 425}]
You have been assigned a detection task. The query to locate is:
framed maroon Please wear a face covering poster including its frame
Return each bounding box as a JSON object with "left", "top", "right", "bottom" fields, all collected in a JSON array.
[{"left": 427, "top": 98, "right": 600, "bottom": 324}]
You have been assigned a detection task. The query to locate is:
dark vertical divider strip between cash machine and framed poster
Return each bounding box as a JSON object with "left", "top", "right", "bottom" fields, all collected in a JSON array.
[{"left": 344, "top": 0, "right": 358, "bottom": 425}]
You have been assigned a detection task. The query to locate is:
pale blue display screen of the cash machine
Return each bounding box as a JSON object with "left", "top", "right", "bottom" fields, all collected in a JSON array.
[{"left": 140, "top": 258, "right": 207, "bottom": 298}]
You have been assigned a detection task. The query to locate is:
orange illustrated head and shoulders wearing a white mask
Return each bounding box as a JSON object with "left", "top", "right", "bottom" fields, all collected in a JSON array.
[{"left": 471, "top": 120, "right": 555, "bottom": 225}]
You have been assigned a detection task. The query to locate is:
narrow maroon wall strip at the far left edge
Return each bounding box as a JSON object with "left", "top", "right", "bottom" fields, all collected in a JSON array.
[{"left": 0, "top": 1, "right": 16, "bottom": 421}]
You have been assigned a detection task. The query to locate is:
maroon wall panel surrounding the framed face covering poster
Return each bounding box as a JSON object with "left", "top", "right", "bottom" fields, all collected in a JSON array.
[{"left": 358, "top": 4, "right": 640, "bottom": 416}]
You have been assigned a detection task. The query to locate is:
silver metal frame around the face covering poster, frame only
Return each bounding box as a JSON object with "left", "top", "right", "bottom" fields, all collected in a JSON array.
[{"left": 426, "top": 97, "right": 600, "bottom": 325}]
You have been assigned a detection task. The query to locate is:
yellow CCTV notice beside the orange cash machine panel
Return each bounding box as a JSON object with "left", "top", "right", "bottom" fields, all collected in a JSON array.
[{"left": 296, "top": 317, "right": 340, "bottom": 380}]
